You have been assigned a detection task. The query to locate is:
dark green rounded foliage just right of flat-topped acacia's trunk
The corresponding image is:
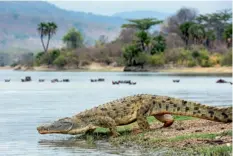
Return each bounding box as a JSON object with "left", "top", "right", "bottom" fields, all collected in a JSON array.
[{"left": 151, "top": 35, "right": 166, "bottom": 55}]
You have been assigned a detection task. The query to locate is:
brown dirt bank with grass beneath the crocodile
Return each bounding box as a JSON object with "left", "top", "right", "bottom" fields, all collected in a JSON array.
[{"left": 88, "top": 118, "right": 232, "bottom": 155}]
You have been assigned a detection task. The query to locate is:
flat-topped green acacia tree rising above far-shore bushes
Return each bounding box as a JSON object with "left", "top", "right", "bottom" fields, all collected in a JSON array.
[{"left": 122, "top": 18, "right": 162, "bottom": 51}]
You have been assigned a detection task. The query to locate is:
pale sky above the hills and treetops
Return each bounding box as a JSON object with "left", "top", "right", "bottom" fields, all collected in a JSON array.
[{"left": 47, "top": 0, "right": 232, "bottom": 16}]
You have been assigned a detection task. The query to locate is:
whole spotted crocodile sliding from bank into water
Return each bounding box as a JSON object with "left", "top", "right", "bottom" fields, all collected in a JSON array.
[{"left": 37, "top": 94, "right": 232, "bottom": 137}]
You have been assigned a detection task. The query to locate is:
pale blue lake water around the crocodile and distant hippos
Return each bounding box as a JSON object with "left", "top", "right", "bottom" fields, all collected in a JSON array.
[{"left": 0, "top": 70, "right": 232, "bottom": 156}]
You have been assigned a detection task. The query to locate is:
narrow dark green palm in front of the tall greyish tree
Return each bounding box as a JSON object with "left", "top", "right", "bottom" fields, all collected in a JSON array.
[{"left": 179, "top": 22, "right": 194, "bottom": 46}]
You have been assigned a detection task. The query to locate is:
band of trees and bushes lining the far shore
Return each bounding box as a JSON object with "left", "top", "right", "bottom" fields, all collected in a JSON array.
[{"left": 8, "top": 8, "right": 232, "bottom": 68}]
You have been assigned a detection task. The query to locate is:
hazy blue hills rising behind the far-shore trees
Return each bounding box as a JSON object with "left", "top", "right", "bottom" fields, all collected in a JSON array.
[{"left": 0, "top": 1, "right": 166, "bottom": 52}]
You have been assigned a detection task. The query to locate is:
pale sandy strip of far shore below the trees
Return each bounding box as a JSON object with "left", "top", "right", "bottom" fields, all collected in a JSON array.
[{"left": 0, "top": 63, "right": 232, "bottom": 74}]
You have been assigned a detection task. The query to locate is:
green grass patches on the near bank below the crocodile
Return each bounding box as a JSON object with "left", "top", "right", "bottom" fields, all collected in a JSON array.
[{"left": 79, "top": 116, "right": 232, "bottom": 156}]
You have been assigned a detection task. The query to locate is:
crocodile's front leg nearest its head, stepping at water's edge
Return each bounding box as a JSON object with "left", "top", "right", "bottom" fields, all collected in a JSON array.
[{"left": 95, "top": 116, "right": 119, "bottom": 137}]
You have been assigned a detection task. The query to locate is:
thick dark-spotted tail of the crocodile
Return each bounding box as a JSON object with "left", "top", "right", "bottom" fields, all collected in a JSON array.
[{"left": 152, "top": 97, "right": 232, "bottom": 123}]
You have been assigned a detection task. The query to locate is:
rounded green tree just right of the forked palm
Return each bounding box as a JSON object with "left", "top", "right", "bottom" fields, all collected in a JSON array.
[{"left": 62, "top": 28, "right": 83, "bottom": 49}]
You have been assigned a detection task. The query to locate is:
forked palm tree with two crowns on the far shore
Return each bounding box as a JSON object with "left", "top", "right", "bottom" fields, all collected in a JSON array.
[{"left": 37, "top": 22, "right": 57, "bottom": 52}]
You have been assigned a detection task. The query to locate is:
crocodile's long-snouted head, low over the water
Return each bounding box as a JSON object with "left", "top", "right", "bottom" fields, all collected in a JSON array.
[{"left": 37, "top": 117, "right": 92, "bottom": 134}]
